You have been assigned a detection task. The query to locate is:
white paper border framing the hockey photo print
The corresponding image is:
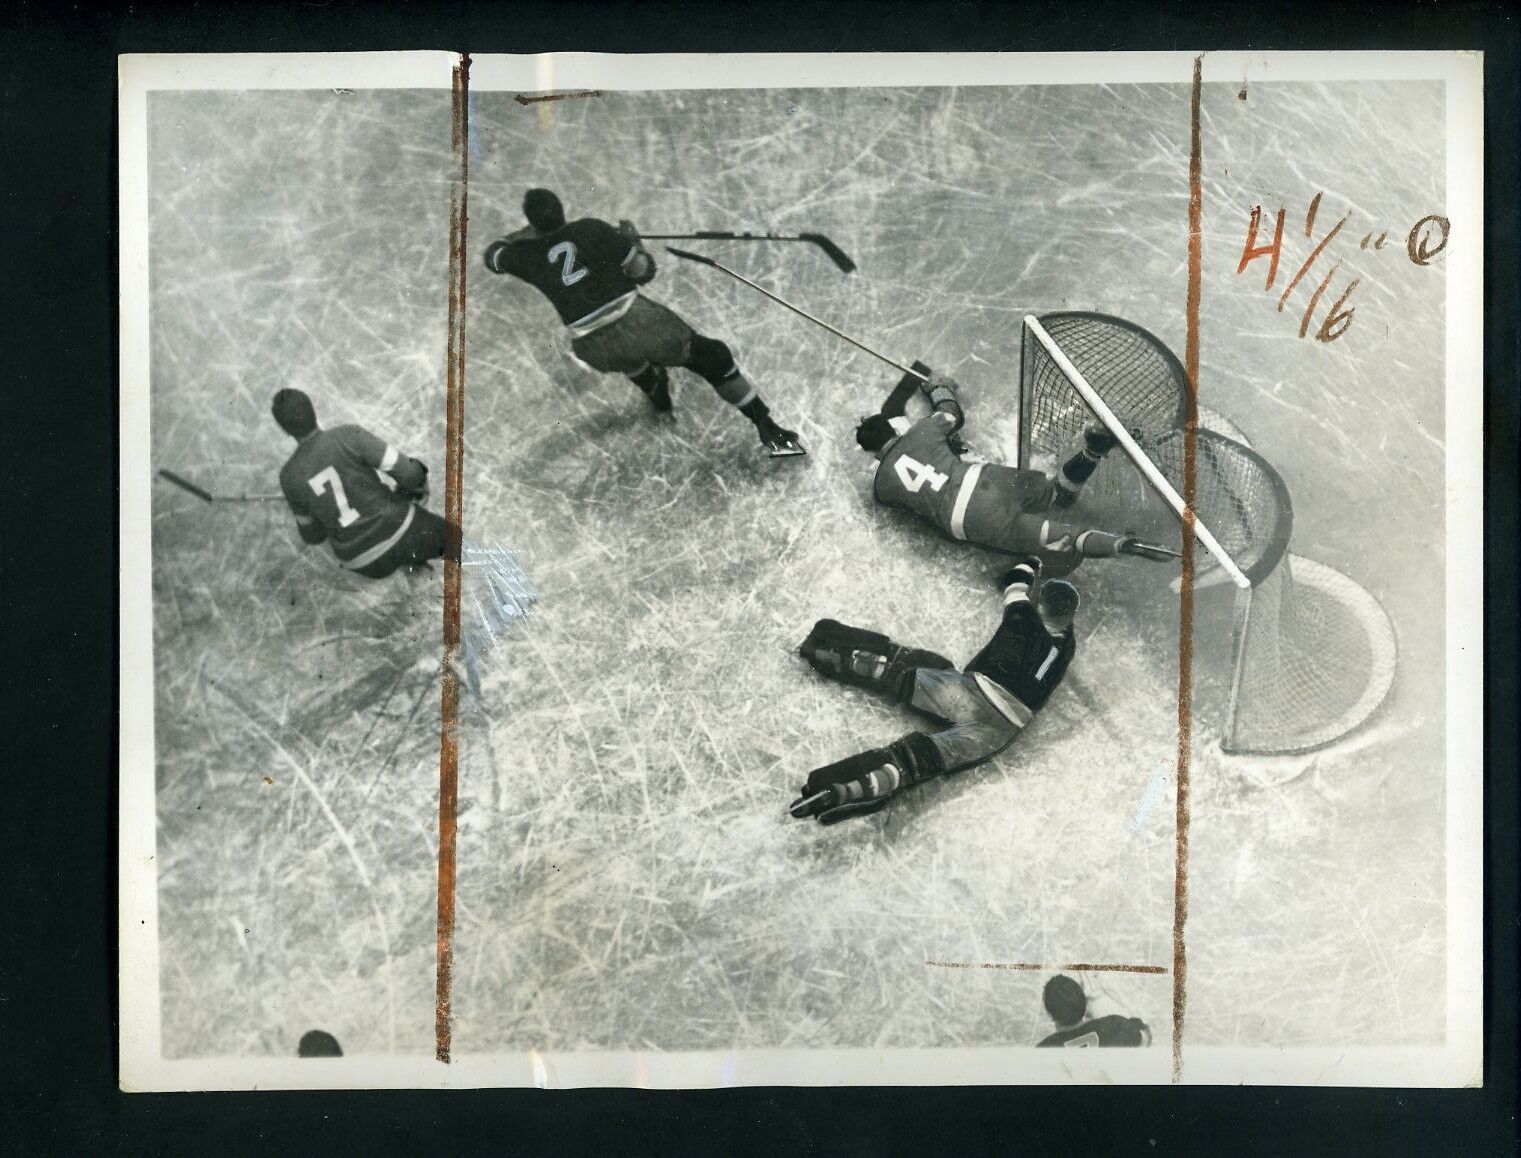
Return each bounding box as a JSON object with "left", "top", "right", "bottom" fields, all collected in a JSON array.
[{"left": 119, "top": 52, "right": 1484, "bottom": 1091}]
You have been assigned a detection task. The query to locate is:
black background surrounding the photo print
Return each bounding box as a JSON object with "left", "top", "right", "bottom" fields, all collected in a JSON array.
[{"left": 0, "top": 0, "right": 1521, "bottom": 1156}]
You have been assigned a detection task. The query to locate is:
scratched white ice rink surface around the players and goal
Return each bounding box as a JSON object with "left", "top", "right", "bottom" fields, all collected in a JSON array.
[{"left": 149, "top": 78, "right": 1445, "bottom": 1056}]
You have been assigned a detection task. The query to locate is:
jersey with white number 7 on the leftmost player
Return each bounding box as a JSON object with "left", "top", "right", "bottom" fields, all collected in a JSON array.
[{"left": 280, "top": 426, "right": 427, "bottom": 568}]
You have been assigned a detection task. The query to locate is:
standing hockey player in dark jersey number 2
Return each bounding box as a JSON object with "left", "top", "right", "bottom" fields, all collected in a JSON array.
[{"left": 485, "top": 189, "right": 806, "bottom": 458}]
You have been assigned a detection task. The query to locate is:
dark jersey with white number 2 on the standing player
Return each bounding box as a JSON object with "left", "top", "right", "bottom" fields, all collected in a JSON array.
[{"left": 485, "top": 218, "right": 639, "bottom": 327}]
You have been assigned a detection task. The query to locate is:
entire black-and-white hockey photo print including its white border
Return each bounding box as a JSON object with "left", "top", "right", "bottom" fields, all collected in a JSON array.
[{"left": 120, "top": 52, "right": 1484, "bottom": 1090}]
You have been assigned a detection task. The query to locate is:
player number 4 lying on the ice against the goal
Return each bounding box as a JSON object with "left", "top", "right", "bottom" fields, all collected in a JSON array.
[{"left": 856, "top": 374, "right": 1177, "bottom": 575}]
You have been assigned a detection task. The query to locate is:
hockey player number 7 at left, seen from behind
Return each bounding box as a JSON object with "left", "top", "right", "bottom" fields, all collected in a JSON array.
[{"left": 271, "top": 390, "right": 450, "bottom": 578}]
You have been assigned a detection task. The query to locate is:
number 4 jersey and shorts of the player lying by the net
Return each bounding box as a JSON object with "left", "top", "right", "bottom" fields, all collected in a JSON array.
[{"left": 872, "top": 411, "right": 1053, "bottom": 554}]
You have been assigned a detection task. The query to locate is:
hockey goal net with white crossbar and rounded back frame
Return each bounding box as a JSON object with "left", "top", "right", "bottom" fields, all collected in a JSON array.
[{"left": 1019, "top": 312, "right": 1396, "bottom": 756}]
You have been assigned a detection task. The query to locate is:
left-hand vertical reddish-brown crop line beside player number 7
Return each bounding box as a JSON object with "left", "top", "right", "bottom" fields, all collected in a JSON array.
[{"left": 433, "top": 53, "right": 470, "bottom": 1062}]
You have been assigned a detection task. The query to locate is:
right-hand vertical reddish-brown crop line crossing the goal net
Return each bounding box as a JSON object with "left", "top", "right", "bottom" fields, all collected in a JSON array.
[{"left": 1173, "top": 55, "right": 1205, "bottom": 1082}]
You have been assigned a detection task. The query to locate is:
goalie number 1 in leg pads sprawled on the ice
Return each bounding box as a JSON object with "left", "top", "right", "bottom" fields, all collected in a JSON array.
[{"left": 792, "top": 558, "right": 1078, "bottom": 825}]
